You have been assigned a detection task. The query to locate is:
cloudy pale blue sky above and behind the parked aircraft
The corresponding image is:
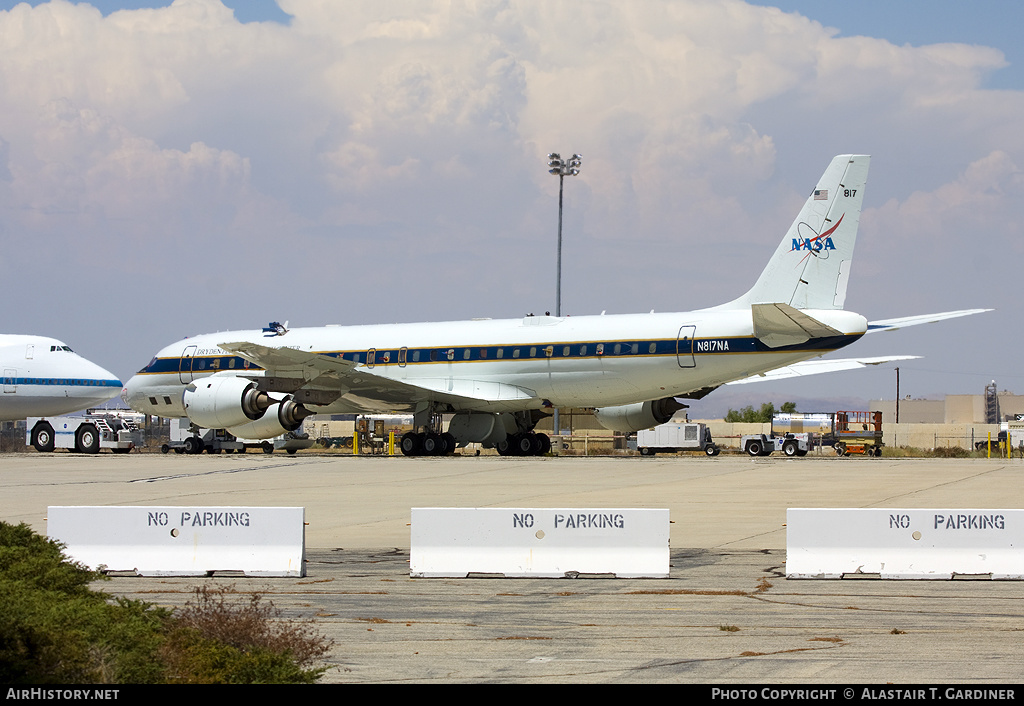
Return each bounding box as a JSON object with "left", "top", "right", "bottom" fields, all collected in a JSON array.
[{"left": 0, "top": 0, "right": 1024, "bottom": 415}]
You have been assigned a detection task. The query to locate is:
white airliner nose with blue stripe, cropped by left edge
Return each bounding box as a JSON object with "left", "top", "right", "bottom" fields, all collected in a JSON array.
[{"left": 0, "top": 334, "right": 121, "bottom": 421}]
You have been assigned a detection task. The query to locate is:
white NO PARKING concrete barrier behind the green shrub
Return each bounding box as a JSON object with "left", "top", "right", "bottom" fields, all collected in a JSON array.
[{"left": 47, "top": 506, "right": 305, "bottom": 576}]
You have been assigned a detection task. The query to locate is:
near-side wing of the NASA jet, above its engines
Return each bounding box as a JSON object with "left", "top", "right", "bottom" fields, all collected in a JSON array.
[{"left": 219, "top": 341, "right": 537, "bottom": 411}]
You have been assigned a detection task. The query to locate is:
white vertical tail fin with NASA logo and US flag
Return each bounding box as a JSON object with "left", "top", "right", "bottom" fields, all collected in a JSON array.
[{"left": 721, "top": 155, "right": 870, "bottom": 309}]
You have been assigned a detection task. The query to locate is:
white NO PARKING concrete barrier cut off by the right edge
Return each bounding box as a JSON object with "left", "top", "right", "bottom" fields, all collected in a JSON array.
[{"left": 785, "top": 508, "right": 1024, "bottom": 581}]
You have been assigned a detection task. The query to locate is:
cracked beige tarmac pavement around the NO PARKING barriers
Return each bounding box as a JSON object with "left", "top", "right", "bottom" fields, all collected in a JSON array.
[{"left": 0, "top": 453, "right": 1024, "bottom": 684}]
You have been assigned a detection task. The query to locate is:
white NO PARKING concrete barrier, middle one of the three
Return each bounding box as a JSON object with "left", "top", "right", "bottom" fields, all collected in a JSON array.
[{"left": 410, "top": 507, "right": 669, "bottom": 578}]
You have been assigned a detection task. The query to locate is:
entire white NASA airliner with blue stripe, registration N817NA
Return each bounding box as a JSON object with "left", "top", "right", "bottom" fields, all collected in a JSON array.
[{"left": 123, "top": 155, "right": 987, "bottom": 455}]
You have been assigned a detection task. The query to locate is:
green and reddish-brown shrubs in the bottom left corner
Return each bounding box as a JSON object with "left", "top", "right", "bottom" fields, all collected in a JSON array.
[{"left": 0, "top": 522, "right": 332, "bottom": 684}]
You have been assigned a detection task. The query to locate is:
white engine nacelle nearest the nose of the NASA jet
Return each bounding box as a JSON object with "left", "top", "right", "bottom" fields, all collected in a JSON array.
[{"left": 181, "top": 375, "right": 273, "bottom": 429}]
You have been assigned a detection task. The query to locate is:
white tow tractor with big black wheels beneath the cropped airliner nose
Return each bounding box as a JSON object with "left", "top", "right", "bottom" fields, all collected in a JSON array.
[{"left": 25, "top": 412, "right": 143, "bottom": 454}]
